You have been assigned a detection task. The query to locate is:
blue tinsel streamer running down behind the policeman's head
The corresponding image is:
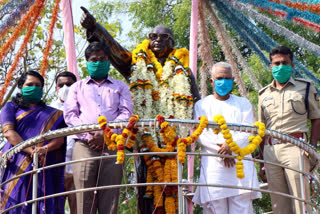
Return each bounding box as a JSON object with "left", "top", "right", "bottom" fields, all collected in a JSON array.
[{"left": 215, "top": 1, "right": 320, "bottom": 90}]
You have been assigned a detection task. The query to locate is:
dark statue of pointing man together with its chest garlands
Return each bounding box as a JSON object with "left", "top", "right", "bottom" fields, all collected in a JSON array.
[{"left": 81, "top": 7, "right": 200, "bottom": 213}]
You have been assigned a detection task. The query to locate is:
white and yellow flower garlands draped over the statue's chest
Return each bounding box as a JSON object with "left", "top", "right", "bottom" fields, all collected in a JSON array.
[{"left": 130, "top": 40, "right": 193, "bottom": 119}]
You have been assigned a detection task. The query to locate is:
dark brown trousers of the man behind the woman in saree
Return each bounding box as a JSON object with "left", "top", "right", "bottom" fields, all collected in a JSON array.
[{"left": 64, "top": 173, "right": 77, "bottom": 214}]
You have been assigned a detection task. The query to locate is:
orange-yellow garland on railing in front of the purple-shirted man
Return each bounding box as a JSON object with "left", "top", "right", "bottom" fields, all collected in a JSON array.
[{"left": 98, "top": 115, "right": 139, "bottom": 164}]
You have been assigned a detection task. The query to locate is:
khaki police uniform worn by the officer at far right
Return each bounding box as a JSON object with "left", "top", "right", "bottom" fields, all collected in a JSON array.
[{"left": 258, "top": 78, "right": 320, "bottom": 214}]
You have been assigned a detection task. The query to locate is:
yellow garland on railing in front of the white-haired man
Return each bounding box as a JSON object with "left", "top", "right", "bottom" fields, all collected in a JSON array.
[{"left": 213, "top": 115, "right": 266, "bottom": 179}]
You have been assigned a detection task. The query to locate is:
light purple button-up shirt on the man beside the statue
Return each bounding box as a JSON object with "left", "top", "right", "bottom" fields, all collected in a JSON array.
[{"left": 64, "top": 77, "right": 133, "bottom": 140}]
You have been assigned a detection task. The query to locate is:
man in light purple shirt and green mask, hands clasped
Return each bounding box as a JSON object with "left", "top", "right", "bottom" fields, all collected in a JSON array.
[{"left": 64, "top": 42, "right": 133, "bottom": 214}]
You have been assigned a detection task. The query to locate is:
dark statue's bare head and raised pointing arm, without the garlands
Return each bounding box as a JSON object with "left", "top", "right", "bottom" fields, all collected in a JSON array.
[{"left": 81, "top": 7, "right": 201, "bottom": 102}]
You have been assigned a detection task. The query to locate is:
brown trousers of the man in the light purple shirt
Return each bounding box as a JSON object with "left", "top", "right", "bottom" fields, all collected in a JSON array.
[{"left": 72, "top": 141, "right": 122, "bottom": 214}]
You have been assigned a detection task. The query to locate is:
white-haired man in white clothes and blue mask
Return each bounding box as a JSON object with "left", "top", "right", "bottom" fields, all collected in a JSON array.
[{"left": 193, "top": 62, "right": 261, "bottom": 214}]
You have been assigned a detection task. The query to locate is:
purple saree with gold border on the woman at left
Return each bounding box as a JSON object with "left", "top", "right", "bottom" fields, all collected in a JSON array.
[{"left": 1, "top": 102, "right": 66, "bottom": 214}]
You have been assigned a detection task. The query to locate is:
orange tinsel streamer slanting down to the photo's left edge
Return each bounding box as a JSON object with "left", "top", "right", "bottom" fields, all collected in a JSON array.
[{"left": 0, "top": 1, "right": 45, "bottom": 103}]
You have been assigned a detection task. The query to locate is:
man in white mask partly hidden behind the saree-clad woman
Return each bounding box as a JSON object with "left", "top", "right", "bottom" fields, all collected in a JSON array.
[{"left": 51, "top": 71, "right": 77, "bottom": 214}]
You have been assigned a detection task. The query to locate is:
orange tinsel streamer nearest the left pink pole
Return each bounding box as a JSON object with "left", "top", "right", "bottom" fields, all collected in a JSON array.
[{"left": 40, "top": 0, "right": 61, "bottom": 76}]
